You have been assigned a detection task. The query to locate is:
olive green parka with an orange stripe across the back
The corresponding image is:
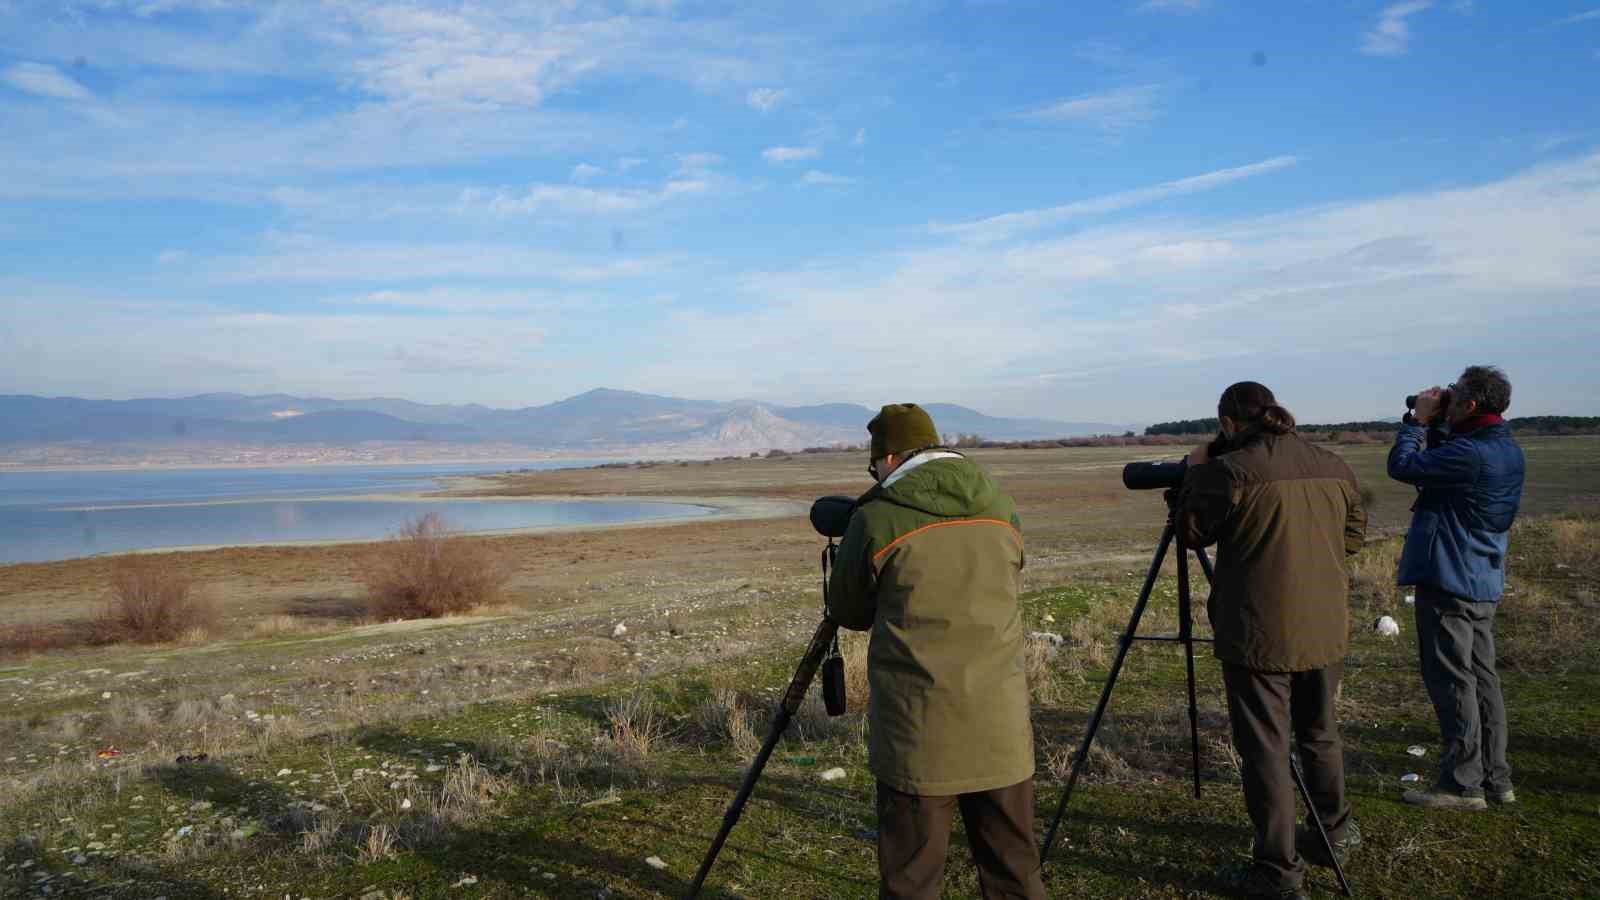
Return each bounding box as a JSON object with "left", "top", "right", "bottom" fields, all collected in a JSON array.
[{"left": 829, "top": 450, "right": 1034, "bottom": 796}]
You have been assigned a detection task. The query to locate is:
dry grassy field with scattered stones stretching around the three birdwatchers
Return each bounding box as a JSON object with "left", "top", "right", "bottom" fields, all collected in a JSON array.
[{"left": 0, "top": 437, "right": 1600, "bottom": 900}]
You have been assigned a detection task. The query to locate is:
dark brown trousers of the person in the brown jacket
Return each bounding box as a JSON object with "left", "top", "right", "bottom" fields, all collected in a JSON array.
[{"left": 1222, "top": 663, "right": 1350, "bottom": 887}]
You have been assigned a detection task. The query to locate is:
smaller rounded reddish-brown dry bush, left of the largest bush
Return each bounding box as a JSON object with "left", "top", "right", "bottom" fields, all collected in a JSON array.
[{"left": 94, "top": 556, "right": 218, "bottom": 644}]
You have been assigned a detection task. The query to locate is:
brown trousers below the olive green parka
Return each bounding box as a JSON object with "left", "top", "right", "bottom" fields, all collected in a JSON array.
[{"left": 878, "top": 778, "right": 1045, "bottom": 900}]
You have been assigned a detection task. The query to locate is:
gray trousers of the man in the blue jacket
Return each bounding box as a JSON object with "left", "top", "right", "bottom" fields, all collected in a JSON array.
[{"left": 1416, "top": 585, "right": 1510, "bottom": 798}]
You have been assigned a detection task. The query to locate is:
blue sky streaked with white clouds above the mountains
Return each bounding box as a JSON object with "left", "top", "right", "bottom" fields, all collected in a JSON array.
[{"left": 0, "top": 0, "right": 1600, "bottom": 423}]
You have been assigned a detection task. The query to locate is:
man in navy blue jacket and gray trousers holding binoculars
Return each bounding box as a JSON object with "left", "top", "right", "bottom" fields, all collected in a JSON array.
[{"left": 1389, "top": 365, "right": 1525, "bottom": 809}]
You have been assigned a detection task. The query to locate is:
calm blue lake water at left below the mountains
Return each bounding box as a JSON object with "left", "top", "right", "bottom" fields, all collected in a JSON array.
[{"left": 0, "top": 460, "right": 710, "bottom": 564}]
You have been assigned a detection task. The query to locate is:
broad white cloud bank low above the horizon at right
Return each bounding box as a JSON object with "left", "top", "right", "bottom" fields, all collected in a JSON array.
[{"left": 620, "top": 154, "right": 1600, "bottom": 421}]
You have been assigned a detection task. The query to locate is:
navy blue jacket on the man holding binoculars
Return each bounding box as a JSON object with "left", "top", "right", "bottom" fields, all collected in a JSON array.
[{"left": 1389, "top": 424, "right": 1525, "bottom": 601}]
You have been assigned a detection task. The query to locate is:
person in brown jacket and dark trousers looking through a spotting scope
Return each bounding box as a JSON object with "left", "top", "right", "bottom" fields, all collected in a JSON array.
[{"left": 1176, "top": 381, "right": 1366, "bottom": 897}]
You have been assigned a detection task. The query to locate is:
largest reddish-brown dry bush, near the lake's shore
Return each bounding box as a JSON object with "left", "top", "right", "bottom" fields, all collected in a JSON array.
[{"left": 362, "top": 512, "right": 509, "bottom": 621}]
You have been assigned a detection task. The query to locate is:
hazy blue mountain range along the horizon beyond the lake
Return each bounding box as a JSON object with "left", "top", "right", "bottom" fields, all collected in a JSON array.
[{"left": 0, "top": 388, "right": 1131, "bottom": 453}]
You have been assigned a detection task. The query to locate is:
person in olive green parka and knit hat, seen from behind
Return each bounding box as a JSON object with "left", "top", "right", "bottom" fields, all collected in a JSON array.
[{"left": 827, "top": 404, "right": 1045, "bottom": 898}]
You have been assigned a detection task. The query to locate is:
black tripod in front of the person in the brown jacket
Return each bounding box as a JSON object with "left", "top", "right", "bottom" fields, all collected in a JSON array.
[{"left": 1038, "top": 501, "right": 1352, "bottom": 897}]
